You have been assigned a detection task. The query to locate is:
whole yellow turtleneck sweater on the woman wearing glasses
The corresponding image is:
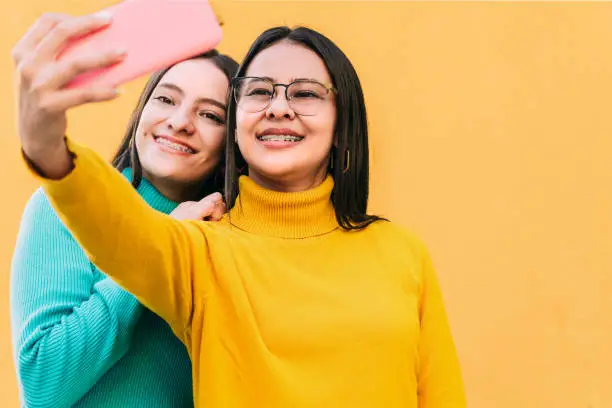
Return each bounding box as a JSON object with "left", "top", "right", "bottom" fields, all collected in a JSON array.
[{"left": 29, "top": 142, "right": 466, "bottom": 408}]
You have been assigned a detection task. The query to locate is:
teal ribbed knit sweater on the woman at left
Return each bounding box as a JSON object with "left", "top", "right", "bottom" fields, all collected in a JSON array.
[{"left": 10, "top": 170, "right": 193, "bottom": 408}]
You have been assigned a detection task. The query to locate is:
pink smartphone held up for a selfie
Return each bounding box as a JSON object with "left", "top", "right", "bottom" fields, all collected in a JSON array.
[{"left": 58, "top": 0, "right": 222, "bottom": 88}]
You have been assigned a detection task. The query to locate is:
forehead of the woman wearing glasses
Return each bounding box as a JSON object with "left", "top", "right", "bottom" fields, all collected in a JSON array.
[{"left": 246, "top": 41, "right": 331, "bottom": 83}]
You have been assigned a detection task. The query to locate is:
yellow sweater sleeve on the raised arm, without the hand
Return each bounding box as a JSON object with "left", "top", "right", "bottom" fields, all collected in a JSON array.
[{"left": 32, "top": 142, "right": 218, "bottom": 335}]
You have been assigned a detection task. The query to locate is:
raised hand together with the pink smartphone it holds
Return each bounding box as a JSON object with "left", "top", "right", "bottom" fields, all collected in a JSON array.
[{"left": 11, "top": 0, "right": 221, "bottom": 179}]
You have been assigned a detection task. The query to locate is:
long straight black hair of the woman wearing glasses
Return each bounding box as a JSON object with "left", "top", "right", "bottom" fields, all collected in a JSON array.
[{"left": 225, "top": 27, "right": 382, "bottom": 230}]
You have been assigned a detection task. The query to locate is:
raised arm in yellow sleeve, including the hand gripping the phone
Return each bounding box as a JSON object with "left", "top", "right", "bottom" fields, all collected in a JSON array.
[{"left": 13, "top": 16, "right": 218, "bottom": 338}]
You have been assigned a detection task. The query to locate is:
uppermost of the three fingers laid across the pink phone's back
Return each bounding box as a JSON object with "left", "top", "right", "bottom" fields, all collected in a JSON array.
[{"left": 36, "top": 12, "right": 112, "bottom": 61}]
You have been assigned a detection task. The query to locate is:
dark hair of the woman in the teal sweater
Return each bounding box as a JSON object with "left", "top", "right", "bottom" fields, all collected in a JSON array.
[{"left": 112, "top": 50, "right": 238, "bottom": 197}]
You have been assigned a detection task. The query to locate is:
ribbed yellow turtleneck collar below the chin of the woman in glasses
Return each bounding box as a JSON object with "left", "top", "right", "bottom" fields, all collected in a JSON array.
[{"left": 229, "top": 175, "right": 338, "bottom": 239}]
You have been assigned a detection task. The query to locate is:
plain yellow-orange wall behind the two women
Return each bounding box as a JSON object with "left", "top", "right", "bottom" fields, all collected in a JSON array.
[{"left": 0, "top": 0, "right": 612, "bottom": 408}]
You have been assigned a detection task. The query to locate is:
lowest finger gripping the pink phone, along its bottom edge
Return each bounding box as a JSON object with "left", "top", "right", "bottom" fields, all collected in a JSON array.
[{"left": 39, "top": 87, "right": 119, "bottom": 114}]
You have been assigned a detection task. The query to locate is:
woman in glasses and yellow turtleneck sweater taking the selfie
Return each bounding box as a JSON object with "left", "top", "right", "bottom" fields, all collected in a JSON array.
[{"left": 15, "top": 11, "right": 466, "bottom": 408}]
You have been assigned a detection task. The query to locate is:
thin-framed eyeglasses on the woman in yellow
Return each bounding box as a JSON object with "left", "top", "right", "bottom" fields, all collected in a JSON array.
[{"left": 232, "top": 77, "right": 337, "bottom": 116}]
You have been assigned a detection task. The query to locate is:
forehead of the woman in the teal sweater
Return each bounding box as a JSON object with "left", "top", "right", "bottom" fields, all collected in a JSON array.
[{"left": 158, "top": 58, "right": 229, "bottom": 101}]
